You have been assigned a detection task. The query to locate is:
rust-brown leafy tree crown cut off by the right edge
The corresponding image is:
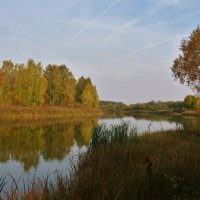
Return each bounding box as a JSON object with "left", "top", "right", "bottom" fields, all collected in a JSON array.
[{"left": 171, "top": 27, "right": 200, "bottom": 96}]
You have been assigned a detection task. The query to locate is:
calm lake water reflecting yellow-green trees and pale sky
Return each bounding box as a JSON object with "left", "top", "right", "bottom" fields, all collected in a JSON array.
[{"left": 0, "top": 115, "right": 200, "bottom": 193}]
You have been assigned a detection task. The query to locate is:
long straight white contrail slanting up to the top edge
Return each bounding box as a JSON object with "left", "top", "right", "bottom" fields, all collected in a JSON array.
[{"left": 68, "top": 0, "right": 120, "bottom": 45}]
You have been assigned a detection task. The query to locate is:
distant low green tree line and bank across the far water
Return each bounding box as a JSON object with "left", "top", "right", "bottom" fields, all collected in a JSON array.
[{"left": 100, "top": 95, "right": 200, "bottom": 116}]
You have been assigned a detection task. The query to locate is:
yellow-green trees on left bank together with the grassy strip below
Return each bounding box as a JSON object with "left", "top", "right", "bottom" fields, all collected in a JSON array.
[{"left": 0, "top": 59, "right": 101, "bottom": 118}]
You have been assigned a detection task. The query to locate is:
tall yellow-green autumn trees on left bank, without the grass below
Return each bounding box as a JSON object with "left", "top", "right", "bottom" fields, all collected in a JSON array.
[{"left": 0, "top": 59, "right": 99, "bottom": 107}]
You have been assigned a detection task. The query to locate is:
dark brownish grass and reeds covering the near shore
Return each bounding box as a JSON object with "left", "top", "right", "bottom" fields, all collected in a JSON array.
[{"left": 1, "top": 124, "right": 200, "bottom": 200}]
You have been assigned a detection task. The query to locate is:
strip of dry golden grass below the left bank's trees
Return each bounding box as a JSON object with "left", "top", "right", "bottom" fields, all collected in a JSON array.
[{"left": 0, "top": 106, "right": 102, "bottom": 119}]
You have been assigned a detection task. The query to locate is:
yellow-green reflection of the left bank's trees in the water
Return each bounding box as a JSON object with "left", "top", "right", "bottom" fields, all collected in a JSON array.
[{"left": 0, "top": 119, "right": 98, "bottom": 171}]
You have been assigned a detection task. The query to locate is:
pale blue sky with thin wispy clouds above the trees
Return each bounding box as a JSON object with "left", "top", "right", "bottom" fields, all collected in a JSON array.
[{"left": 0, "top": 0, "right": 200, "bottom": 104}]
